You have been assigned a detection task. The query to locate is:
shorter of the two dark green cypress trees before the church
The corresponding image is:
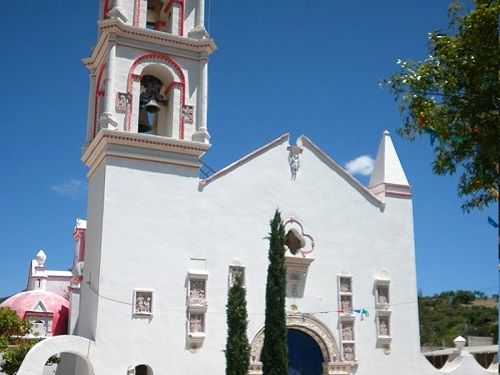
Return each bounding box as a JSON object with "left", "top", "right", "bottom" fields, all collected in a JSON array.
[{"left": 226, "top": 277, "right": 250, "bottom": 375}]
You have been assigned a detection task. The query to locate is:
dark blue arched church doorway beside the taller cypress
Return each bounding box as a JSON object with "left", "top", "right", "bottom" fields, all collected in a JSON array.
[{"left": 288, "top": 328, "right": 324, "bottom": 375}]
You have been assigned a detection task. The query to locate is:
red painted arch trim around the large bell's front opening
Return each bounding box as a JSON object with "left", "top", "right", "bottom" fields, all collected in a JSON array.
[{"left": 125, "top": 52, "right": 186, "bottom": 139}]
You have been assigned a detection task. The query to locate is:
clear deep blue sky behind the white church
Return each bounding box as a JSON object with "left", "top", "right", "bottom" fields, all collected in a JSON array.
[{"left": 0, "top": 0, "right": 498, "bottom": 296}]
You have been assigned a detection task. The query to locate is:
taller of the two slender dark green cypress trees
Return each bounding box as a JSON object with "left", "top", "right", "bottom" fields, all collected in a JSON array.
[{"left": 261, "top": 210, "right": 288, "bottom": 375}]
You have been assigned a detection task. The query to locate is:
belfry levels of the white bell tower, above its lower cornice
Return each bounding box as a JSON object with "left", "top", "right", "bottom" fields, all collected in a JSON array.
[{"left": 84, "top": 0, "right": 216, "bottom": 148}]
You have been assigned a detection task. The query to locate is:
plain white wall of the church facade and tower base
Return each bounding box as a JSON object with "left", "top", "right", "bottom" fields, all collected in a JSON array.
[{"left": 76, "top": 136, "right": 444, "bottom": 375}]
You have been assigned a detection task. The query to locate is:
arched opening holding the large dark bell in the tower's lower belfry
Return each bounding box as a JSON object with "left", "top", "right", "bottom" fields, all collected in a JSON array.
[{"left": 137, "top": 65, "right": 176, "bottom": 137}]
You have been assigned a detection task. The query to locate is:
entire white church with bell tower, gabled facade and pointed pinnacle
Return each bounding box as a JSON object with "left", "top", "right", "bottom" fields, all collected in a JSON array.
[{"left": 18, "top": 0, "right": 498, "bottom": 375}]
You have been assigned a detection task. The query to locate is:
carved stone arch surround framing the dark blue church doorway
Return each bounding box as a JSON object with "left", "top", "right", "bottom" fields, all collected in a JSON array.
[{"left": 249, "top": 313, "right": 350, "bottom": 375}]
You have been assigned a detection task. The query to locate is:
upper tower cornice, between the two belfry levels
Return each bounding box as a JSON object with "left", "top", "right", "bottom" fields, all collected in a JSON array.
[{"left": 83, "top": 18, "right": 217, "bottom": 69}]
